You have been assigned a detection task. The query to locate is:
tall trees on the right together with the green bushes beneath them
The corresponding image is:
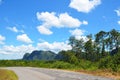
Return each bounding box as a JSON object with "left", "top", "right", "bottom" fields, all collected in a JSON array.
[{"left": 56, "top": 29, "right": 120, "bottom": 72}]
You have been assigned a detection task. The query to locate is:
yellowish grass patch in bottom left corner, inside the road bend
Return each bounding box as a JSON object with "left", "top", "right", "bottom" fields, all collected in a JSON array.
[{"left": 0, "top": 69, "right": 18, "bottom": 80}]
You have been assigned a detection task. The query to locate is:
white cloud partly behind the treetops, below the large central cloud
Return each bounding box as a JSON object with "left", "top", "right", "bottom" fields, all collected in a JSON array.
[{"left": 69, "top": 29, "right": 88, "bottom": 42}]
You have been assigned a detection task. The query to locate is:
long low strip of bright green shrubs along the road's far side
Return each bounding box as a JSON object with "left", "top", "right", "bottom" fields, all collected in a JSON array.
[{"left": 0, "top": 60, "right": 98, "bottom": 70}]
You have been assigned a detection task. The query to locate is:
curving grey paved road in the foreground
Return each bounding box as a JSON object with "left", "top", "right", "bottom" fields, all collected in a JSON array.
[{"left": 7, "top": 67, "right": 113, "bottom": 80}]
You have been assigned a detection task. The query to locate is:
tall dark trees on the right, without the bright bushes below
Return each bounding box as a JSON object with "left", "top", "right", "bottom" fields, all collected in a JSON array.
[{"left": 57, "top": 29, "right": 120, "bottom": 62}]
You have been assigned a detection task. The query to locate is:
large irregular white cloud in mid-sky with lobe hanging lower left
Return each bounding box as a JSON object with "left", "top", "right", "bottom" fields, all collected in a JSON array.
[{"left": 37, "top": 12, "right": 88, "bottom": 35}]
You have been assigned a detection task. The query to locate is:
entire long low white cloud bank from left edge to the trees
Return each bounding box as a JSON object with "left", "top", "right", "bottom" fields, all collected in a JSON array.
[{"left": 0, "top": 41, "right": 71, "bottom": 57}]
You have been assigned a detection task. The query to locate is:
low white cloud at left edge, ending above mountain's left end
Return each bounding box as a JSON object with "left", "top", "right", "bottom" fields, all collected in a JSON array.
[{"left": 0, "top": 45, "right": 36, "bottom": 55}]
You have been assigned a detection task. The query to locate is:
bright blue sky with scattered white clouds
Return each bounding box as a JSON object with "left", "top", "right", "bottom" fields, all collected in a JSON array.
[{"left": 0, "top": 0, "right": 120, "bottom": 59}]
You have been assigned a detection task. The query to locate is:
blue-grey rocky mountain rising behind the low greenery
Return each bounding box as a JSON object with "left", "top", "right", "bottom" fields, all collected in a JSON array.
[{"left": 23, "top": 50, "right": 56, "bottom": 60}]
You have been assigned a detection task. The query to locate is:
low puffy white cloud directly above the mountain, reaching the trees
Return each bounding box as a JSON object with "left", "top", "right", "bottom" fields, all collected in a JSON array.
[{"left": 37, "top": 42, "right": 71, "bottom": 52}]
